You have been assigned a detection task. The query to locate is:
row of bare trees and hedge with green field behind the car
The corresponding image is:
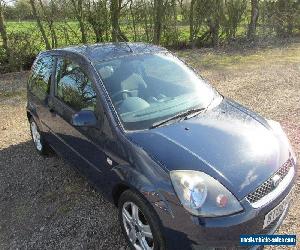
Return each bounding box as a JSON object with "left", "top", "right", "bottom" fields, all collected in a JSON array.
[{"left": 0, "top": 0, "right": 300, "bottom": 72}]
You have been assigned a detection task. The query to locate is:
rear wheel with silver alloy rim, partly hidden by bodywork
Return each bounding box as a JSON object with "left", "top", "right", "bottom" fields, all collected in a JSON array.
[{"left": 29, "top": 117, "right": 50, "bottom": 156}]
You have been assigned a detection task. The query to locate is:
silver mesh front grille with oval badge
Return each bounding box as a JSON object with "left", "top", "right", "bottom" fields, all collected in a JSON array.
[{"left": 247, "top": 160, "right": 293, "bottom": 203}]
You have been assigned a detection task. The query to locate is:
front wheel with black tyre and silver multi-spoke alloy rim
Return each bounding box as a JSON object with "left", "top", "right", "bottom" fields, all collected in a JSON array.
[{"left": 118, "top": 190, "right": 166, "bottom": 250}]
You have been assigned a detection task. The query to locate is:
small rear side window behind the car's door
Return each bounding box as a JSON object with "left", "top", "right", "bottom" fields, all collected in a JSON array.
[{"left": 29, "top": 56, "right": 54, "bottom": 100}]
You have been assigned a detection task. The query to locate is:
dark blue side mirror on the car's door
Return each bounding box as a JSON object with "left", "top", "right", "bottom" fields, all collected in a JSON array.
[{"left": 71, "top": 110, "right": 97, "bottom": 127}]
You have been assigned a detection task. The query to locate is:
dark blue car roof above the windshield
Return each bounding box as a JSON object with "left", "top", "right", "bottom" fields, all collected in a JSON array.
[{"left": 47, "top": 42, "right": 167, "bottom": 62}]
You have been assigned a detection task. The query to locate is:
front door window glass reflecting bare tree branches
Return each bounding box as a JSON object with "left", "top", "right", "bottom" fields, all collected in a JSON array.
[{"left": 56, "top": 59, "right": 96, "bottom": 111}]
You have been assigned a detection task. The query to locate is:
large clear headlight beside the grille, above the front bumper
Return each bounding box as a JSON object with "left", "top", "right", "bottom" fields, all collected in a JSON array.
[{"left": 170, "top": 170, "right": 243, "bottom": 217}]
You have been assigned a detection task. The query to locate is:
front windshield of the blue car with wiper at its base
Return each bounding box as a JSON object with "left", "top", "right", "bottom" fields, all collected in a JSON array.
[{"left": 95, "top": 52, "right": 219, "bottom": 130}]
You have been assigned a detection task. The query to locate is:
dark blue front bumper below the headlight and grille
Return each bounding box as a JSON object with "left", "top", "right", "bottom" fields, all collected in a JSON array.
[{"left": 154, "top": 167, "right": 296, "bottom": 250}]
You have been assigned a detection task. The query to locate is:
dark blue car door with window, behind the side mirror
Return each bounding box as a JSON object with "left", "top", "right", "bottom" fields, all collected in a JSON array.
[{"left": 49, "top": 54, "right": 115, "bottom": 183}]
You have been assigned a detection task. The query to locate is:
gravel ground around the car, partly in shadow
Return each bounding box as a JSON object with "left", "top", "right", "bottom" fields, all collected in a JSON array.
[{"left": 0, "top": 43, "right": 300, "bottom": 249}]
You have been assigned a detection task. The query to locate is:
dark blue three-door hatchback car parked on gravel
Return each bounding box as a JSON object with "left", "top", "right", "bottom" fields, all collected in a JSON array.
[{"left": 27, "top": 43, "right": 296, "bottom": 249}]
